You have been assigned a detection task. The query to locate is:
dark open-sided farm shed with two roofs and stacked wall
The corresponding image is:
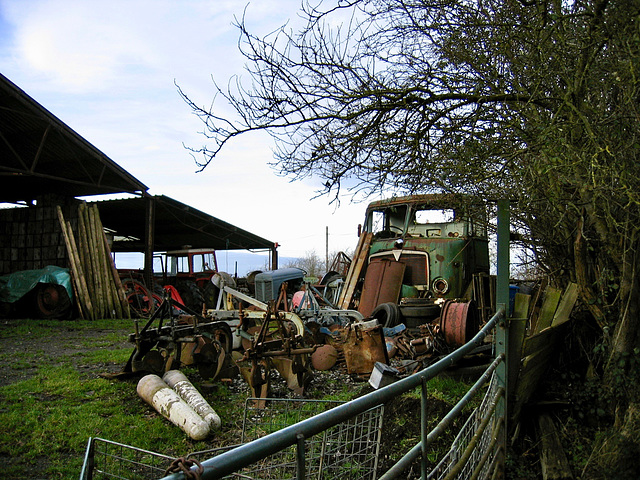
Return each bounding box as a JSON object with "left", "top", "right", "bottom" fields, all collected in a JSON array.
[{"left": 0, "top": 74, "right": 275, "bottom": 275}]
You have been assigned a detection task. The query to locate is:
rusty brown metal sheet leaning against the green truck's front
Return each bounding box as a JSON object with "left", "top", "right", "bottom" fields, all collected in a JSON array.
[{"left": 358, "top": 259, "right": 405, "bottom": 317}]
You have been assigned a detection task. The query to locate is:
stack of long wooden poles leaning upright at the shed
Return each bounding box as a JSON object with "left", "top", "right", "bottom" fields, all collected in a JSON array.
[{"left": 58, "top": 203, "right": 131, "bottom": 320}]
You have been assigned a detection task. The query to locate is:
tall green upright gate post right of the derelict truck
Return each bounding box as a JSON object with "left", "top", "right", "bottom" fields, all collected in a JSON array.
[{"left": 494, "top": 200, "right": 511, "bottom": 469}]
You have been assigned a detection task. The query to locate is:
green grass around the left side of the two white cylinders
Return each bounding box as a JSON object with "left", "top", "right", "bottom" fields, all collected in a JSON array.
[{"left": 0, "top": 320, "right": 241, "bottom": 478}]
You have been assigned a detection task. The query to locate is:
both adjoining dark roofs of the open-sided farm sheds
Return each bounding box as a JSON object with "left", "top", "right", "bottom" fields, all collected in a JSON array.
[{"left": 0, "top": 74, "right": 274, "bottom": 252}]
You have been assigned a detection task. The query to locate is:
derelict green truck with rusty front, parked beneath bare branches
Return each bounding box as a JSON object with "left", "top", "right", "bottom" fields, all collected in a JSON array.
[{"left": 350, "top": 194, "right": 495, "bottom": 346}]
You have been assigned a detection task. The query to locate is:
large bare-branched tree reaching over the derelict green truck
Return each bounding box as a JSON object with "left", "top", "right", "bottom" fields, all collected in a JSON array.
[{"left": 183, "top": 0, "right": 640, "bottom": 472}]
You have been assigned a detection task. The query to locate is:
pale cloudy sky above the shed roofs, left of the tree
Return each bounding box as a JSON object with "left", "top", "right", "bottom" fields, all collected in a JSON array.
[{"left": 0, "top": 0, "right": 380, "bottom": 274}]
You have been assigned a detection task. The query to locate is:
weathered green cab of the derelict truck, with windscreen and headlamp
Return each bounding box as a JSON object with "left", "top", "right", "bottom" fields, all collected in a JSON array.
[{"left": 364, "top": 194, "right": 489, "bottom": 298}]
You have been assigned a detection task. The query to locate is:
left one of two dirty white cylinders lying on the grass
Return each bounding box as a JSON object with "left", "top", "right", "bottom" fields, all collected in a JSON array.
[{"left": 137, "top": 375, "right": 209, "bottom": 440}]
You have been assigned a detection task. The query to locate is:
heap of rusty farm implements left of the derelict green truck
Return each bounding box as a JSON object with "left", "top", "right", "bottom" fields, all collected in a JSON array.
[{"left": 124, "top": 268, "right": 388, "bottom": 404}]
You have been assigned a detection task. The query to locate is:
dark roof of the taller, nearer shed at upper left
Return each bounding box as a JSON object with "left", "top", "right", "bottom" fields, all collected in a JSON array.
[{"left": 0, "top": 74, "right": 148, "bottom": 203}]
